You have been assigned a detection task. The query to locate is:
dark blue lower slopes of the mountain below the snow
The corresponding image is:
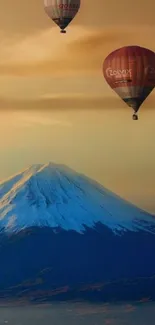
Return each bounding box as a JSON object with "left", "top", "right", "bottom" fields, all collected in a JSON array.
[{"left": 0, "top": 223, "right": 155, "bottom": 301}]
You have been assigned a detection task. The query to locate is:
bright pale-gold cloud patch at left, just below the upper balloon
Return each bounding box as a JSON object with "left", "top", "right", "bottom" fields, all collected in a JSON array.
[{"left": 0, "top": 27, "right": 90, "bottom": 65}]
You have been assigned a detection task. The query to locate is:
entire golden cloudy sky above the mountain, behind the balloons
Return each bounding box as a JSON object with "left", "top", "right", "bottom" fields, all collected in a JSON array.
[{"left": 0, "top": 0, "right": 155, "bottom": 213}]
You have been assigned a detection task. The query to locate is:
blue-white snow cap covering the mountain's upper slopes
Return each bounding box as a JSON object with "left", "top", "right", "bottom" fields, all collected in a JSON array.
[{"left": 0, "top": 163, "right": 155, "bottom": 234}]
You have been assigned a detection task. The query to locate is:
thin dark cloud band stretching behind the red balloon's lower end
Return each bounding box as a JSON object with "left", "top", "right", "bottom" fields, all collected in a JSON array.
[{"left": 0, "top": 94, "right": 155, "bottom": 112}]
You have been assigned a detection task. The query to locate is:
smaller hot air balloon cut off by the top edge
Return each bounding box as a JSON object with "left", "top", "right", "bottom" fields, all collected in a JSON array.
[{"left": 44, "top": 0, "right": 80, "bottom": 33}]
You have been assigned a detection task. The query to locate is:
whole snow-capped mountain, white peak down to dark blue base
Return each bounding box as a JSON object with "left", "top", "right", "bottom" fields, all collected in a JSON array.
[{"left": 0, "top": 163, "right": 155, "bottom": 301}]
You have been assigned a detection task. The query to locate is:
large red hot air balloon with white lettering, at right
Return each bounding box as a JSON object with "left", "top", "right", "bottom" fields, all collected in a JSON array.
[{"left": 103, "top": 46, "right": 155, "bottom": 120}]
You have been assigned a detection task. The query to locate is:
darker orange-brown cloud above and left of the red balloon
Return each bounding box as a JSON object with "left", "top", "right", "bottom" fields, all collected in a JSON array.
[{"left": 68, "top": 26, "right": 155, "bottom": 69}]
